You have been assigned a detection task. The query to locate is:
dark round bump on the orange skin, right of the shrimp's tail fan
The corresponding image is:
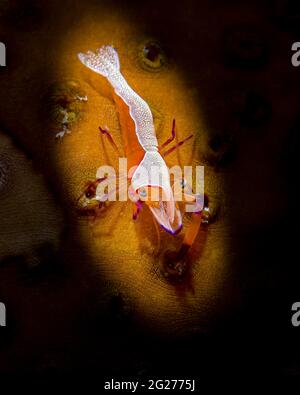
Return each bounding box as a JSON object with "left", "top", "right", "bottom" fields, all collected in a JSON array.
[{"left": 139, "top": 41, "right": 166, "bottom": 71}]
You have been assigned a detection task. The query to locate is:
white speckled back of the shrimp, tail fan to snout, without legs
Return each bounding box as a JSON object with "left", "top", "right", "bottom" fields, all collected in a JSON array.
[{"left": 78, "top": 46, "right": 181, "bottom": 233}]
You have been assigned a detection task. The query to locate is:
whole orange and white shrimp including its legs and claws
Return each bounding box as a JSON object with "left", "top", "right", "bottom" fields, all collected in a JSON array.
[{"left": 78, "top": 46, "right": 203, "bottom": 246}]
